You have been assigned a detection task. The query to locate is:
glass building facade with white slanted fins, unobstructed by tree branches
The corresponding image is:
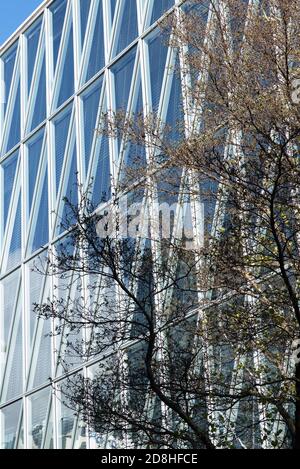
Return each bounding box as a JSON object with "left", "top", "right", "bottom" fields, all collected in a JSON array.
[{"left": 0, "top": 0, "right": 181, "bottom": 449}]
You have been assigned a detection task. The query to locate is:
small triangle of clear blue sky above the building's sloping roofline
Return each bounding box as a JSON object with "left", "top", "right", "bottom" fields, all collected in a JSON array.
[{"left": 0, "top": 0, "right": 42, "bottom": 46}]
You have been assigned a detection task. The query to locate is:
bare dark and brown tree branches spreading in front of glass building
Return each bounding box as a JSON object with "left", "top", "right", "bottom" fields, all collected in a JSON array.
[{"left": 36, "top": 0, "right": 300, "bottom": 449}]
